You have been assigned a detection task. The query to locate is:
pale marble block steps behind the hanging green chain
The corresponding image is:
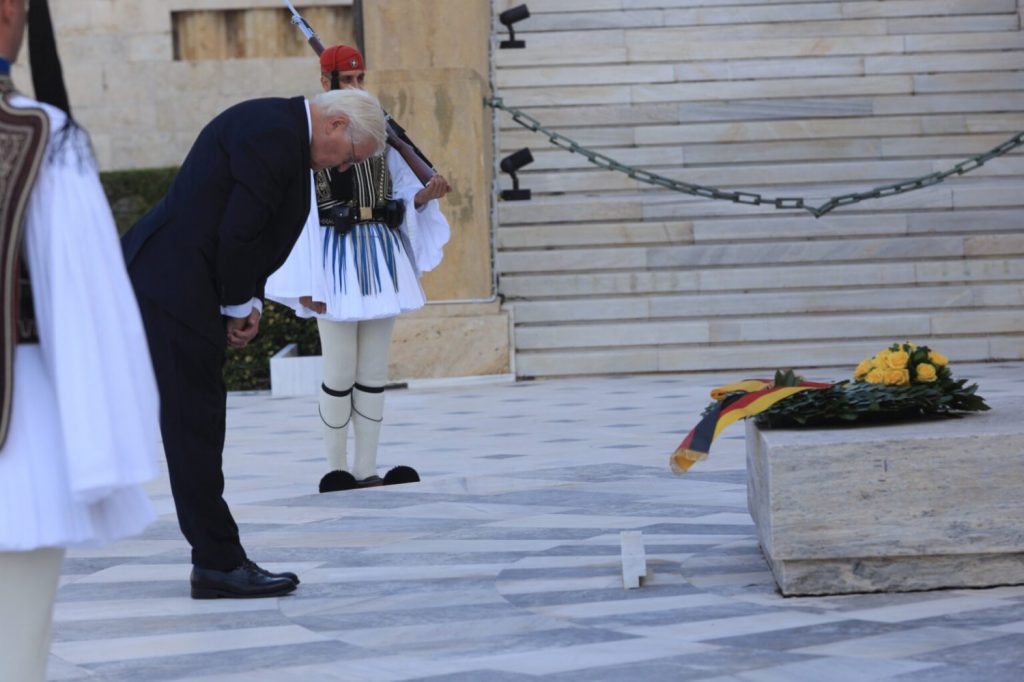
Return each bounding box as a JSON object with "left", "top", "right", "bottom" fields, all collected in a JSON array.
[{"left": 495, "top": 0, "right": 1024, "bottom": 377}]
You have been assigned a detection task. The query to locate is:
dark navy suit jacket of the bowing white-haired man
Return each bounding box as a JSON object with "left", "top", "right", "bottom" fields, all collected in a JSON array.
[{"left": 122, "top": 97, "right": 310, "bottom": 346}]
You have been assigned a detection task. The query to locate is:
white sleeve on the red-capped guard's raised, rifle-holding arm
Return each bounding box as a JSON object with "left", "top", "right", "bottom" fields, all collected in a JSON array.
[{"left": 387, "top": 147, "right": 452, "bottom": 274}]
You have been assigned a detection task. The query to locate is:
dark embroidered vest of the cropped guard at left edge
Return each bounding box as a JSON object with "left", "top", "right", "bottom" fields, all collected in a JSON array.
[{"left": 0, "top": 76, "right": 50, "bottom": 446}]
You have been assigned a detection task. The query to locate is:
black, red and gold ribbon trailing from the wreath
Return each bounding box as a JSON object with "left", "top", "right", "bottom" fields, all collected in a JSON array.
[{"left": 669, "top": 379, "right": 831, "bottom": 475}]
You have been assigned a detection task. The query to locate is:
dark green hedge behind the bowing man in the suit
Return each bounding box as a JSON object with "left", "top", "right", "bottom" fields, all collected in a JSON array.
[{"left": 99, "top": 168, "right": 319, "bottom": 391}]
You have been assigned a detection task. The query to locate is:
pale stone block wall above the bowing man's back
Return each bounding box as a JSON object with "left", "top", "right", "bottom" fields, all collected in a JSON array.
[{"left": 15, "top": 0, "right": 351, "bottom": 170}]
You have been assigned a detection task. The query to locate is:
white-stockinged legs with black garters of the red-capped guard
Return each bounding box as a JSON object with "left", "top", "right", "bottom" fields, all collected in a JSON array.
[{"left": 316, "top": 317, "right": 394, "bottom": 480}]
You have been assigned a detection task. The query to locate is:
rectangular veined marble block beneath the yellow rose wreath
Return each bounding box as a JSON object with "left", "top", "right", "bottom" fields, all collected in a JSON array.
[{"left": 746, "top": 398, "right": 1024, "bottom": 595}]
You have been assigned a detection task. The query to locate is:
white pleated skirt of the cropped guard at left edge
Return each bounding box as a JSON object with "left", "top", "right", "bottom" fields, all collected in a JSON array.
[{"left": 0, "top": 344, "right": 156, "bottom": 551}]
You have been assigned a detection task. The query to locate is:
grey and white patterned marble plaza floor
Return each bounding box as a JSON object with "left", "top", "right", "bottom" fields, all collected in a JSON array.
[{"left": 49, "top": 364, "right": 1024, "bottom": 682}]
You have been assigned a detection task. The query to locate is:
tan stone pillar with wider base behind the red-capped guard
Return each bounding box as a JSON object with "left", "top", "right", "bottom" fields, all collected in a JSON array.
[{"left": 364, "top": 0, "right": 511, "bottom": 378}]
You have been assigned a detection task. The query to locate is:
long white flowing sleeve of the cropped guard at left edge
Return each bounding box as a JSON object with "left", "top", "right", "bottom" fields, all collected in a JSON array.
[{"left": 25, "top": 102, "right": 160, "bottom": 505}]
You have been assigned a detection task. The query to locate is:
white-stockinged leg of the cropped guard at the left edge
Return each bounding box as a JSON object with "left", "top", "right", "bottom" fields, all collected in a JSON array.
[{"left": 0, "top": 547, "right": 65, "bottom": 682}]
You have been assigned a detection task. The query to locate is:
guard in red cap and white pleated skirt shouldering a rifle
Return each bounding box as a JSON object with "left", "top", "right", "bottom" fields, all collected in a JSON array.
[{"left": 266, "top": 41, "right": 451, "bottom": 493}]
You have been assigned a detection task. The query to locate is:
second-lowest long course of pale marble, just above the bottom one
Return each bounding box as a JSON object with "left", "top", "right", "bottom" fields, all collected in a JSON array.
[{"left": 514, "top": 307, "right": 1024, "bottom": 352}]
